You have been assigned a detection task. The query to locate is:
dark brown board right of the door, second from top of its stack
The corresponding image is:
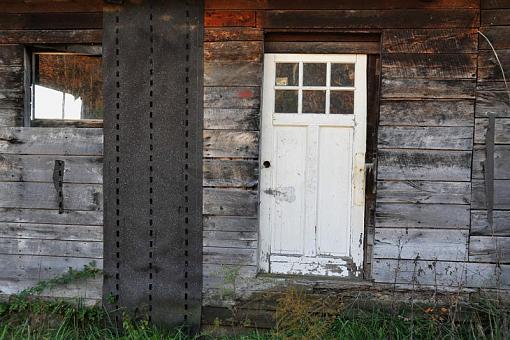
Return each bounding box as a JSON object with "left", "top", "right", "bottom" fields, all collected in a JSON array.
[{"left": 381, "top": 53, "right": 477, "bottom": 79}]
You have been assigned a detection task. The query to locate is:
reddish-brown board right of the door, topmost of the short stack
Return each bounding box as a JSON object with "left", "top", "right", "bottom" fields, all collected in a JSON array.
[{"left": 382, "top": 29, "right": 478, "bottom": 53}]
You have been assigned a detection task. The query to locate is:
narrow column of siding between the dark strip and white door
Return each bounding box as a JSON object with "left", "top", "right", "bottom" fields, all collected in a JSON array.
[{"left": 203, "top": 22, "right": 264, "bottom": 305}]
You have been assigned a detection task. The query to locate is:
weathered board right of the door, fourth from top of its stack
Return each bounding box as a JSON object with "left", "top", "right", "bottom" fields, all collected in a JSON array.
[{"left": 379, "top": 97, "right": 478, "bottom": 126}]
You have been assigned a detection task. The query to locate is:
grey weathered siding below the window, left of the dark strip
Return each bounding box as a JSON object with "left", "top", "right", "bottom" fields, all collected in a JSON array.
[{"left": 0, "top": 127, "right": 103, "bottom": 301}]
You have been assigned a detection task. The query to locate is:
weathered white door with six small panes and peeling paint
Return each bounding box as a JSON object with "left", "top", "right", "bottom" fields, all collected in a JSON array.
[{"left": 259, "top": 54, "right": 367, "bottom": 276}]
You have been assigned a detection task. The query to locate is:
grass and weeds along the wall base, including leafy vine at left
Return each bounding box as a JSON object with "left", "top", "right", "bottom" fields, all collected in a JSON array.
[{"left": 0, "top": 263, "right": 510, "bottom": 340}]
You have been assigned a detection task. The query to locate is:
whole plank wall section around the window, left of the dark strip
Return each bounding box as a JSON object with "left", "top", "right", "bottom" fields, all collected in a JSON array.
[{"left": 0, "top": 0, "right": 103, "bottom": 301}]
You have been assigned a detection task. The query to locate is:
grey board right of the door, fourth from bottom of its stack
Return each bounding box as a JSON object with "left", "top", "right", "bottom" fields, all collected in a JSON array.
[{"left": 377, "top": 181, "right": 471, "bottom": 204}]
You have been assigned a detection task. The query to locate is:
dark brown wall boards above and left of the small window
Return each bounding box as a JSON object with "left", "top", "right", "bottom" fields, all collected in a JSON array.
[{"left": 0, "top": 0, "right": 102, "bottom": 126}]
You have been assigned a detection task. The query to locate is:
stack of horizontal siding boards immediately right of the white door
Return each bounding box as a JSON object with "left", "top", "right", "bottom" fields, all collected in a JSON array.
[{"left": 372, "top": 25, "right": 478, "bottom": 286}]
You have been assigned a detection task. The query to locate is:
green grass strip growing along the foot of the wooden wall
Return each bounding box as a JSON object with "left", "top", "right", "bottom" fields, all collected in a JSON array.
[{"left": 0, "top": 298, "right": 510, "bottom": 340}]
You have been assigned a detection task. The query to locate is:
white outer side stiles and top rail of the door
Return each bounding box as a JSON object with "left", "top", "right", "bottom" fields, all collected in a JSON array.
[{"left": 258, "top": 53, "right": 368, "bottom": 276}]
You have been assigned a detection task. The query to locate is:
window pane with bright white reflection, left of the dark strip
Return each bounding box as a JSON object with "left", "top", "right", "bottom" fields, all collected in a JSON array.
[{"left": 32, "top": 53, "right": 103, "bottom": 120}]
